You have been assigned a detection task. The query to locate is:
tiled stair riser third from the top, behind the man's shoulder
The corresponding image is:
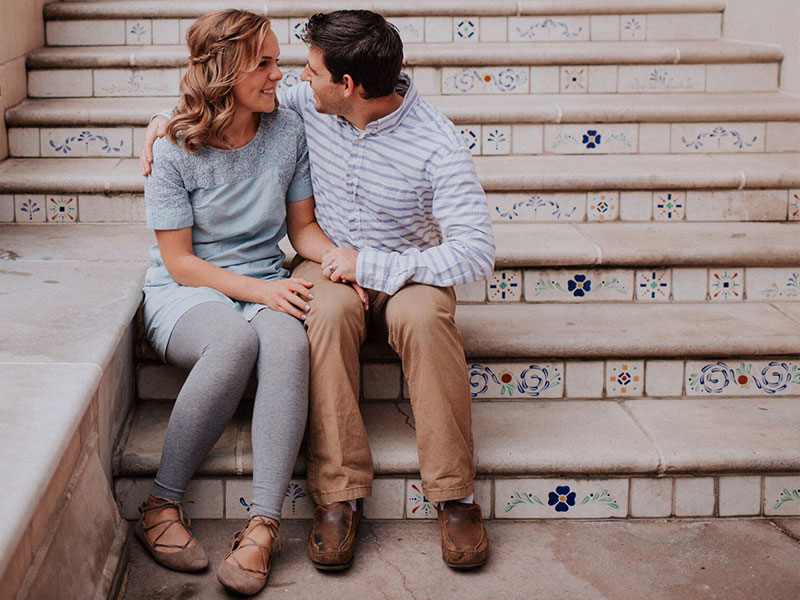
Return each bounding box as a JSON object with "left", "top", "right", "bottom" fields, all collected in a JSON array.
[{"left": 8, "top": 121, "right": 800, "bottom": 158}]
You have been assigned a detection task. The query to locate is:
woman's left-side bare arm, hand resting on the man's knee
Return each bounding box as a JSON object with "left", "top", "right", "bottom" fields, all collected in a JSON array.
[{"left": 155, "top": 227, "right": 314, "bottom": 319}]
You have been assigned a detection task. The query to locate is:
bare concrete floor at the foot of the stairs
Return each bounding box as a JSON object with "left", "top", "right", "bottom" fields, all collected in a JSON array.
[{"left": 124, "top": 519, "right": 800, "bottom": 600}]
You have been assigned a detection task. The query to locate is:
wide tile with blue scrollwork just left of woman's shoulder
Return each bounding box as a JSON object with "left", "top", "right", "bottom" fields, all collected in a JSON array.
[{"left": 41, "top": 127, "right": 133, "bottom": 157}]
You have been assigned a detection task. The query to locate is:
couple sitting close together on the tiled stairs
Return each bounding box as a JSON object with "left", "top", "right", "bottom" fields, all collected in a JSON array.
[{"left": 136, "top": 10, "right": 494, "bottom": 594}]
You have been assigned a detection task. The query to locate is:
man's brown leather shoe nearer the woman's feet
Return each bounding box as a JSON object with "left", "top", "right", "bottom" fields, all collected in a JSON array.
[{"left": 308, "top": 498, "right": 363, "bottom": 571}]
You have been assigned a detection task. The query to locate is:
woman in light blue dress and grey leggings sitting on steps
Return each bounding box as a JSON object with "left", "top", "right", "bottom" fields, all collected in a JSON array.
[{"left": 137, "top": 10, "right": 366, "bottom": 594}]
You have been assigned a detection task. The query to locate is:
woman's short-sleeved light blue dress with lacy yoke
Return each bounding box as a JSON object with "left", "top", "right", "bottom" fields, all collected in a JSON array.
[{"left": 144, "top": 108, "right": 313, "bottom": 358}]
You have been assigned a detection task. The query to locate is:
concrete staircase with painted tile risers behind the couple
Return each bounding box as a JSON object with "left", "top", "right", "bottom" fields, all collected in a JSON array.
[{"left": 0, "top": 0, "right": 800, "bottom": 596}]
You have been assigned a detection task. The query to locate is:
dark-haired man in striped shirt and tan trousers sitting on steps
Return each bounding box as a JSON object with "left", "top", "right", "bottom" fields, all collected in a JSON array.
[{"left": 142, "top": 11, "right": 494, "bottom": 570}]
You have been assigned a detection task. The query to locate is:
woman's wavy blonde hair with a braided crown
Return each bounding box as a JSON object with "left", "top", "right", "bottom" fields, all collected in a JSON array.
[{"left": 167, "top": 9, "right": 269, "bottom": 153}]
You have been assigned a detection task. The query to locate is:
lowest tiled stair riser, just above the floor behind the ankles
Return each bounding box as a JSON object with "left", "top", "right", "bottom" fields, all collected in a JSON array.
[{"left": 115, "top": 473, "right": 800, "bottom": 519}]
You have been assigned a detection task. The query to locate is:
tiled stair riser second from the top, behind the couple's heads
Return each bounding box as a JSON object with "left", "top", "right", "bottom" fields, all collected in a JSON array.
[{"left": 28, "top": 63, "right": 778, "bottom": 98}]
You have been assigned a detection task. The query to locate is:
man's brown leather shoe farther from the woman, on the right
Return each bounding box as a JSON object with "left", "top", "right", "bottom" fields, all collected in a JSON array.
[{"left": 439, "top": 500, "right": 489, "bottom": 569}]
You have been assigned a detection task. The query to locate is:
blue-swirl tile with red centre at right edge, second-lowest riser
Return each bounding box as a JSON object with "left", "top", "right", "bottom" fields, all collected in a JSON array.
[{"left": 686, "top": 359, "right": 800, "bottom": 396}]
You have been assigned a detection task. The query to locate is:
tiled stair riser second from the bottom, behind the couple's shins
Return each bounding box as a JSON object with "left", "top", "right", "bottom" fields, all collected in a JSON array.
[{"left": 137, "top": 357, "right": 800, "bottom": 402}]
